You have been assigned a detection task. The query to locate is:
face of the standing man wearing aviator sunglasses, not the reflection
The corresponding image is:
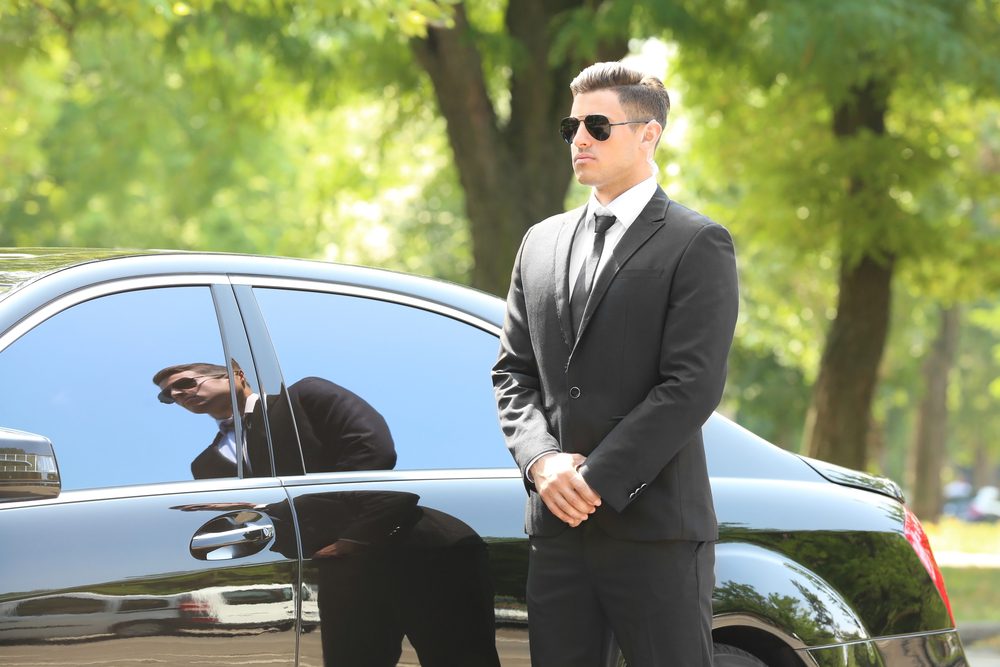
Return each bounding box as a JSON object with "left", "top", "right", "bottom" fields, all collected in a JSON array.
[{"left": 570, "top": 90, "right": 655, "bottom": 204}]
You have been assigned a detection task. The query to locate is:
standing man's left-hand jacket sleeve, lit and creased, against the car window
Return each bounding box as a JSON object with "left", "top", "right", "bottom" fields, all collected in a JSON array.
[{"left": 493, "top": 230, "right": 560, "bottom": 488}]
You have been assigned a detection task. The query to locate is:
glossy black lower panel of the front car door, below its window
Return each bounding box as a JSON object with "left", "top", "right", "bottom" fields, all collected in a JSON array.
[{"left": 0, "top": 481, "right": 297, "bottom": 667}]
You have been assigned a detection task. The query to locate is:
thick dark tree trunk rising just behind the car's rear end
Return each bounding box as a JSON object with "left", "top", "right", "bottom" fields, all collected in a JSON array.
[{"left": 805, "top": 80, "right": 895, "bottom": 470}]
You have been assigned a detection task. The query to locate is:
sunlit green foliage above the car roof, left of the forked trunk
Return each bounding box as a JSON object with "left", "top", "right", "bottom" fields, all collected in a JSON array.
[{"left": 0, "top": 1, "right": 470, "bottom": 280}]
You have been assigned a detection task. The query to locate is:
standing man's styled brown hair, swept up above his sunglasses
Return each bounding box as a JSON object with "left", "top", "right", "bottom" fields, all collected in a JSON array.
[{"left": 569, "top": 62, "right": 670, "bottom": 127}]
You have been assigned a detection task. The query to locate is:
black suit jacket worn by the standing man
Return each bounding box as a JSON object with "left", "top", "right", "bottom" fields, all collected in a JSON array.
[{"left": 493, "top": 188, "right": 739, "bottom": 541}]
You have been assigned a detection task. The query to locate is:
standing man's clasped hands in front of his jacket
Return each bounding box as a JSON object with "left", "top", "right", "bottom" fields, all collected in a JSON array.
[{"left": 528, "top": 453, "right": 601, "bottom": 528}]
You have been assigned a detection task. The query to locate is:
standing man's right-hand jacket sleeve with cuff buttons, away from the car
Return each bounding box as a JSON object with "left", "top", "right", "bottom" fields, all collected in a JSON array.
[{"left": 581, "top": 223, "right": 739, "bottom": 512}]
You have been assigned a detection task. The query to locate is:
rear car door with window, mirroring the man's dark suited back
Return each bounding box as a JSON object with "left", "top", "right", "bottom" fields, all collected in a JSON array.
[{"left": 233, "top": 277, "right": 530, "bottom": 667}]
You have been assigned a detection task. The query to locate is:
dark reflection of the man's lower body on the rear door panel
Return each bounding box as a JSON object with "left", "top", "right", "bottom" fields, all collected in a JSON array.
[{"left": 286, "top": 491, "right": 500, "bottom": 667}]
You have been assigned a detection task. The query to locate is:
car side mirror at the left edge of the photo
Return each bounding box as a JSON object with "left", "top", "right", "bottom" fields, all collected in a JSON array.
[{"left": 0, "top": 427, "right": 62, "bottom": 503}]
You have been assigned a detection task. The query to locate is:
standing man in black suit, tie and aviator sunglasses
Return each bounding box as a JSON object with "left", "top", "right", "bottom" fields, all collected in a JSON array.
[{"left": 493, "top": 63, "right": 738, "bottom": 667}]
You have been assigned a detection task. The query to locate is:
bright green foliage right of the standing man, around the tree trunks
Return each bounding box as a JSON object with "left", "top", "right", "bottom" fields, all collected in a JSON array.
[{"left": 637, "top": 0, "right": 1000, "bottom": 470}]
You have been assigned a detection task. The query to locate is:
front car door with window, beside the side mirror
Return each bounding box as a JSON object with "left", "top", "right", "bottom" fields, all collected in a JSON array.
[{"left": 0, "top": 276, "right": 300, "bottom": 666}]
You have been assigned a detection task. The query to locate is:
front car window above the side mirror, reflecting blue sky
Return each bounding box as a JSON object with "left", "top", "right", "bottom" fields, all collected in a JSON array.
[{"left": 0, "top": 286, "right": 238, "bottom": 490}]
